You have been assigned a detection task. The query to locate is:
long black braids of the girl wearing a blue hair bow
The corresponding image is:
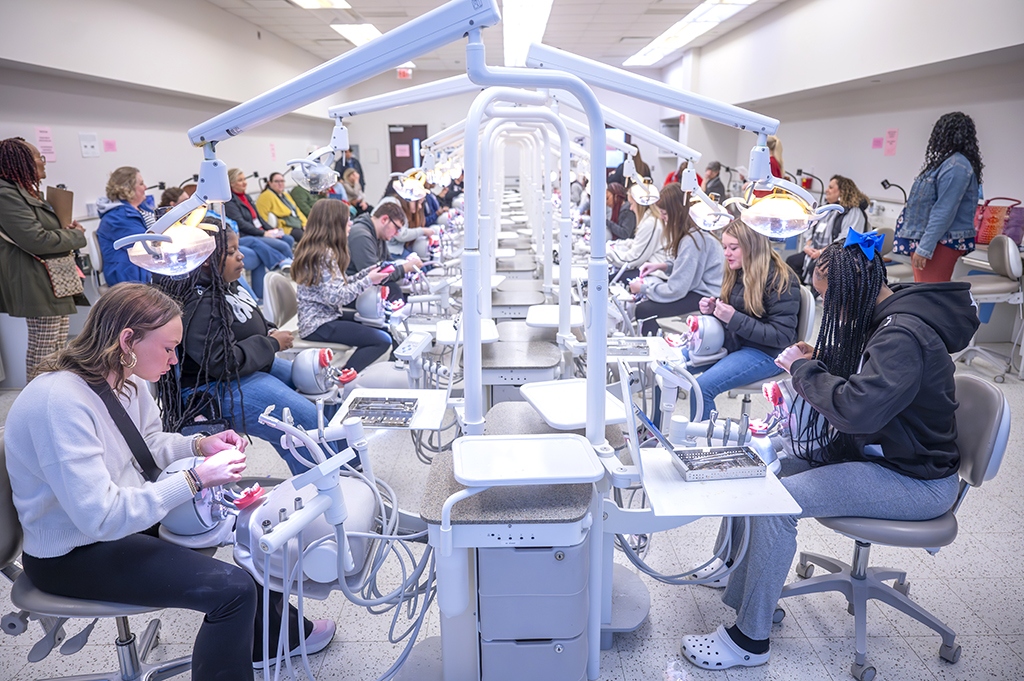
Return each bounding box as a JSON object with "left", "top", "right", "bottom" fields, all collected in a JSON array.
[{"left": 794, "top": 236, "right": 888, "bottom": 466}]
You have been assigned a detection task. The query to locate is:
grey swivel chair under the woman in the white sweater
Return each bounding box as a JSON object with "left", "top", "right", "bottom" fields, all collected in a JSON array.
[{"left": 0, "top": 428, "right": 191, "bottom": 681}]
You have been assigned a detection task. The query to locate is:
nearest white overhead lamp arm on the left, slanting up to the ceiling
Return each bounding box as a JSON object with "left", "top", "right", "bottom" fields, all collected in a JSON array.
[{"left": 188, "top": 0, "right": 501, "bottom": 146}]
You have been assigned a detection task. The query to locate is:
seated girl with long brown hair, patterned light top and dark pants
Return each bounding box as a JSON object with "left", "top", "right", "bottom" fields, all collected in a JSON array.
[{"left": 292, "top": 199, "right": 391, "bottom": 372}]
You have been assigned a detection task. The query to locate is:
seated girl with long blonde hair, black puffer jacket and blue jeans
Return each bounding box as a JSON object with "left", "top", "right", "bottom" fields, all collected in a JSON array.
[{"left": 690, "top": 220, "right": 800, "bottom": 421}]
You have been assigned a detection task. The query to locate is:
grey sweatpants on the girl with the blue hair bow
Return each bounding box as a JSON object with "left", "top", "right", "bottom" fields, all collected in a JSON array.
[{"left": 717, "top": 458, "right": 959, "bottom": 640}]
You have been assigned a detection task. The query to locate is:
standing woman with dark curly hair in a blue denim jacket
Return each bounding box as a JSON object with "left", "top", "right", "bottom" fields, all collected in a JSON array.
[{"left": 893, "top": 112, "right": 984, "bottom": 282}]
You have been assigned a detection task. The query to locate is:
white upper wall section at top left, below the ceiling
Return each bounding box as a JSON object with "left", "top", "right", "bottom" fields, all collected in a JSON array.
[{"left": 0, "top": 0, "right": 342, "bottom": 118}]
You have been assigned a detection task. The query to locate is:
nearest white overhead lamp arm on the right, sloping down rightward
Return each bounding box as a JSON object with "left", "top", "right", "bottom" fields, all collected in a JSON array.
[{"left": 526, "top": 43, "right": 778, "bottom": 135}]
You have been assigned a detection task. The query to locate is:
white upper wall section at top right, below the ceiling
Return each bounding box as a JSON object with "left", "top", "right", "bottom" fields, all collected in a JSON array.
[{"left": 698, "top": 0, "right": 1024, "bottom": 103}]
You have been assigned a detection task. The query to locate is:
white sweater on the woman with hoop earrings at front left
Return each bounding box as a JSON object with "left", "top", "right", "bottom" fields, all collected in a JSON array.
[{"left": 4, "top": 372, "right": 193, "bottom": 558}]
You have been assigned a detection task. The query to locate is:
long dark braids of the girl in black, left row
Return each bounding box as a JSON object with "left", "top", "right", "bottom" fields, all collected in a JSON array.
[{"left": 153, "top": 217, "right": 245, "bottom": 432}]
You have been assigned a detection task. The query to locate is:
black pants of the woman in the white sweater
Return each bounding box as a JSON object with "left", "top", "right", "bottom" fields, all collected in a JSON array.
[{"left": 23, "top": 534, "right": 312, "bottom": 681}]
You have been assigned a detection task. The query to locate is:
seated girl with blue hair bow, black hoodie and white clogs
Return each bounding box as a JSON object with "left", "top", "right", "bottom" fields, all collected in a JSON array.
[{"left": 682, "top": 232, "right": 979, "bottom": 669}]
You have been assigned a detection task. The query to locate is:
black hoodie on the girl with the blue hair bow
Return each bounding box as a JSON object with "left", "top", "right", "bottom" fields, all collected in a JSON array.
[{"left": 791, "top": 283, "right": 980, "bottom": 480}]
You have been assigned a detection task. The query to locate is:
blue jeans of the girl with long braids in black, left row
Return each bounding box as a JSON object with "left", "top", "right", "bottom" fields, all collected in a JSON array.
[{"left": 185, "top": 357, "right": 347, "bottom": 475}]
